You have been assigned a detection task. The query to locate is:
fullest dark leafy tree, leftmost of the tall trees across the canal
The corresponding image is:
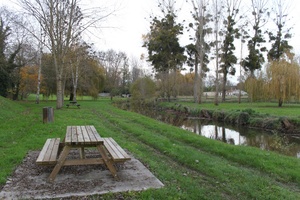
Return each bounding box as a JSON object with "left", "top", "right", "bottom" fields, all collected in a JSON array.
[{"left": 143, "top": 1, "right": 186, "bottom": 100}]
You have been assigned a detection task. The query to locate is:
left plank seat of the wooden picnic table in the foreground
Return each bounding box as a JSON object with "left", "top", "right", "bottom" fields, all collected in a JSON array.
[{"left": 36, "top": 138, "right": 61, "bottom": 165}]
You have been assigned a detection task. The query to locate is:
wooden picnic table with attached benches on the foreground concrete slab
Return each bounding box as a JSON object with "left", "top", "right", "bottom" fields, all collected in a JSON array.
[{"left": 36, "top": 126, "right": 131, "bottom": 181}]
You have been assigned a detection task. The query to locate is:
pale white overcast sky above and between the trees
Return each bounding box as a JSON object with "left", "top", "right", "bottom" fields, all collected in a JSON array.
[{"left": 0, "top": 0, "right": 300, "bottom": 65}]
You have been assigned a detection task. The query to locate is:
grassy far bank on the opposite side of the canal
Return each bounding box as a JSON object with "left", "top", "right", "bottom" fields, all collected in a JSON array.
[{"left": 159, "top": 101, "right": 300, "bottom": 135}]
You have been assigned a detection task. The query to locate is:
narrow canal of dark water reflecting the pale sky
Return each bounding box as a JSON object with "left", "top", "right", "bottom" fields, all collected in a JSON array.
[{"left": 129, "top": 104, "right": 300, "bottom": 158}]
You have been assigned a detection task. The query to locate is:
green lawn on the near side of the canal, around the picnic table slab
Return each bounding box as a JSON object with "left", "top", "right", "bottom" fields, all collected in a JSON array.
[{"left": 0, "top": 98, "right": 300, "bottom": 199}]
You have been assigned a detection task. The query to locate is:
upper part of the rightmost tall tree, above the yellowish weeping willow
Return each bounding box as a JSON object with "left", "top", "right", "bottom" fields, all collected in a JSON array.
[{"left": 268, "top": 0, "right": 293, "bottom": 61}]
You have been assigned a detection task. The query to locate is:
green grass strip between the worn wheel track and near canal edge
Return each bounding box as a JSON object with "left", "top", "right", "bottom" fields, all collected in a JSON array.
[{"left": 96, "top": 103, "right": 300, "bottom": 186}]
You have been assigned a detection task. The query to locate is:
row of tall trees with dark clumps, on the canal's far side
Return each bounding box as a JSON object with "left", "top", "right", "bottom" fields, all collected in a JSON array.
[{"left": 144, "top": 0, "right": 294, "bottom": 105}]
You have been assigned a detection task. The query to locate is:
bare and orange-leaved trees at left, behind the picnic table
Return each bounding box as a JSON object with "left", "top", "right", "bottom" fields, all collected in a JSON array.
[{"left": 0, "top": 0, "right": 141, "bottom": 109}]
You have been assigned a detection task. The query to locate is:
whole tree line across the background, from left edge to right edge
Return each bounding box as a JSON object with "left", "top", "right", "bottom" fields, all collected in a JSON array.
[{"left": 0, "top": 0, "right": 298, "bottom": 108}]
